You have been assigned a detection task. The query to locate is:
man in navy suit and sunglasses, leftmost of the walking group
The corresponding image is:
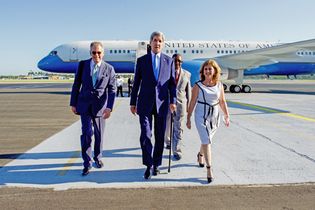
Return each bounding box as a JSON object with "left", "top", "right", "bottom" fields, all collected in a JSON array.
[{"left": 70, "top": 42, "right": 116, "bottom": 176}]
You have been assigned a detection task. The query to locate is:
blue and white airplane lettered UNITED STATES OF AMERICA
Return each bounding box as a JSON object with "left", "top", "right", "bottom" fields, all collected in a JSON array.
[{"left": 37, "top": 39, "right": 315, "bottom": 93}]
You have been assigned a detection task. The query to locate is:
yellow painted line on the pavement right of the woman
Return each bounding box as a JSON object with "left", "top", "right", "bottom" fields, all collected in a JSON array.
[{"left": 228, "top": 101, "right": 315, "bottom": 122}]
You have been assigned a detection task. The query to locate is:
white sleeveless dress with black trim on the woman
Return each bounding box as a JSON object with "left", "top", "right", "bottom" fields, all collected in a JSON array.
[{"left": 195, "top": 81, "right": 222, "bottom": 144}]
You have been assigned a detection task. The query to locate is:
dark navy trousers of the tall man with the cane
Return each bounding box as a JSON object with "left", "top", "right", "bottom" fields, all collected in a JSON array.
[{"left": 139, "top": 108, "right": 166, "bottom": 167}]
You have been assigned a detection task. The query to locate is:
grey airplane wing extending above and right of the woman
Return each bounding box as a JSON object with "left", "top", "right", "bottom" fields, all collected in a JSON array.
[{"left": 215, "top": 39, "right": 315, "bottom": 70}]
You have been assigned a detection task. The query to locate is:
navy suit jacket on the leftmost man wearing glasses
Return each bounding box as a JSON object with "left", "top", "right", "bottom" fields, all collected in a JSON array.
[{"left": 70, "top": 59, "right": 116, "bottom": 117}]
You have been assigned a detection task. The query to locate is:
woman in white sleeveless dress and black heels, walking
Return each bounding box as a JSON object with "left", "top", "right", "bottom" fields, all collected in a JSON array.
[{"left": 187, "top": 60, "right": 230, "bottom": 183}]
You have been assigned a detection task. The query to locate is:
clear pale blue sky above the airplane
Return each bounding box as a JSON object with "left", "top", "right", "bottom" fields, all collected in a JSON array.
[{"left": 0, "top": 0, "right": 315, "bottom": 75}]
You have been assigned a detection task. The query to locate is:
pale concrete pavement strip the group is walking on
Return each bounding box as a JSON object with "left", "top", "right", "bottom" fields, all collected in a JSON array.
[{"left": 0, "top": 81, "right": 315, "bottom": 190}]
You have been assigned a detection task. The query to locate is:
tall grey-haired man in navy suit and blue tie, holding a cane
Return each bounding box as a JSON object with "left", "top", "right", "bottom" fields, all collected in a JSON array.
[{"left": 130, "top": 32, "right": 176, "bottom": 179}]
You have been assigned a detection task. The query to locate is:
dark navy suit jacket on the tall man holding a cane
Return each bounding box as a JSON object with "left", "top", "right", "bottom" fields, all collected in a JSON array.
[{"left": 130, "top": 53, "right": 176, "bottom": 116}]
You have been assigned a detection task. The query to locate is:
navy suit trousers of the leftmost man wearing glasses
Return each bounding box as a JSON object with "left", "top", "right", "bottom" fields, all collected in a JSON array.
[{"left": 81, "top": 110, "right": 105, "bottom": 167}]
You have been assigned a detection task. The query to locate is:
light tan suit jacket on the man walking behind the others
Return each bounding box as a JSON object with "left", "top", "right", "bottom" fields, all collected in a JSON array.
[{"left": 176, "top": 69, "right": 191, "bottom": 115}]
